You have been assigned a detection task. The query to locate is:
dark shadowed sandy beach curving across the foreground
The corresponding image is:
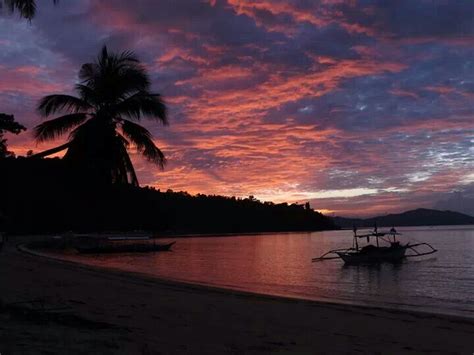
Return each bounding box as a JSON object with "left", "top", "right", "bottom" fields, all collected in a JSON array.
[{"left": 0, "top": 238, "right": 474, "bottom": 355}]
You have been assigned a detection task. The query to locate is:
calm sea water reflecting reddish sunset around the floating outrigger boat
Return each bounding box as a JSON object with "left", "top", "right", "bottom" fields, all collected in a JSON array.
[{"left": 61, "top": 226, "right": 474, "bottom": 318}]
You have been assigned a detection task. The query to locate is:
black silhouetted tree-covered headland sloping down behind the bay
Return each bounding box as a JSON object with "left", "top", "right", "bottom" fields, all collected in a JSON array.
[{"left": 0, "top": 158, "right": 334, "bottom": 233}]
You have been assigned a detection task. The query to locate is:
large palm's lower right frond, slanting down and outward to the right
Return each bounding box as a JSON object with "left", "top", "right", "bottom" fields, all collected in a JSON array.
[{"left": 121, "top": 120, "right": 166, "bottom": 169}]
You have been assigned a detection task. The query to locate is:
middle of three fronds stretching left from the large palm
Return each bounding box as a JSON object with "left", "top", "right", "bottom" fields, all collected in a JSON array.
[{"left": 34, "top": 113, "right": 87, "bottom": 142}]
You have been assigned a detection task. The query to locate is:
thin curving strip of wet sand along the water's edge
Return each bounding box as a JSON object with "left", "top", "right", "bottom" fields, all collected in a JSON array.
[{"left": 21, "top": 242, "right": 474, "bottom": 324}]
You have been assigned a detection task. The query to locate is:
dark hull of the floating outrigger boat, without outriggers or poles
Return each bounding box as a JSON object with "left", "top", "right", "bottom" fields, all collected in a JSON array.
[{"left": 337, "top": 246, "right": 407, "bottom": 264}]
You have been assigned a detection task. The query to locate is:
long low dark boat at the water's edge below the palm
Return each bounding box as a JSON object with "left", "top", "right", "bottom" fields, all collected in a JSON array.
[{"left": 74, "top": 236, "right": 176, "bottom": 254}]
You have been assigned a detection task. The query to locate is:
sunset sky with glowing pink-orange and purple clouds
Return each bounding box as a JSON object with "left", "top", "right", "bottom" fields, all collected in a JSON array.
[{"left": 0, "top": 0, "right": 474, "bottom": 216}]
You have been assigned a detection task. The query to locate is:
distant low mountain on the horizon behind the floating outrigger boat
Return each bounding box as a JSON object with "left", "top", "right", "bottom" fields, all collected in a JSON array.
[{"left": 333, "top": 208, "right": 474, "bottom": 228}]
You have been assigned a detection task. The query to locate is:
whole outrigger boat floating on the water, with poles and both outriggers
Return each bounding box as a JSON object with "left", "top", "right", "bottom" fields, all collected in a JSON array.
[{"left": 313, "top": 226, "right": 437, "bottom": 264}]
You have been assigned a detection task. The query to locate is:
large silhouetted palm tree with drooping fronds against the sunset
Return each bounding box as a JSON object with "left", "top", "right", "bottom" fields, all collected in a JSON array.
[{"left": 33, "top": 46, "right": 168, "bottom": 186}]
